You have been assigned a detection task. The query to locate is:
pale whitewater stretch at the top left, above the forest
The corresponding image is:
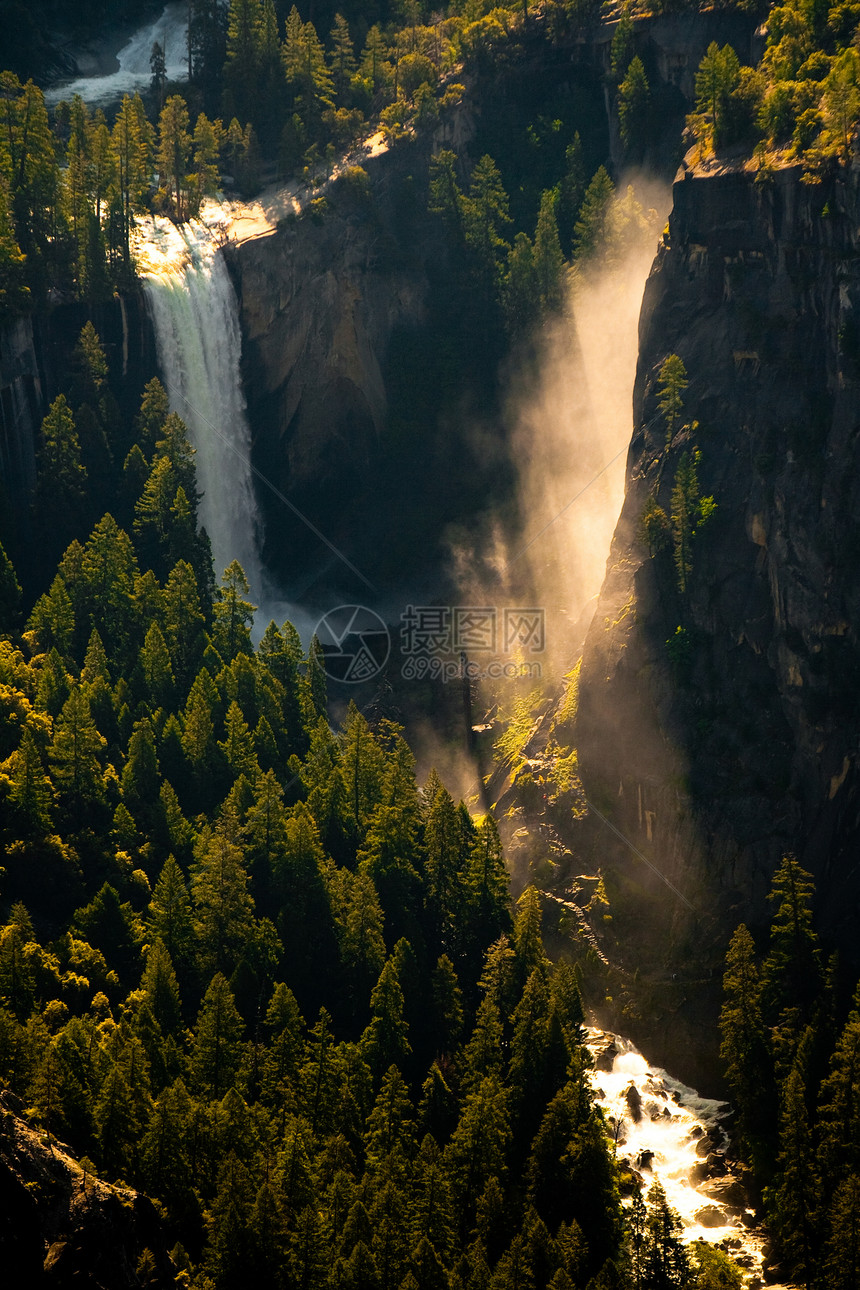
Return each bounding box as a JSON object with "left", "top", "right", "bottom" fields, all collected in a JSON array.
[{"left": 45, "top": 4, "right": 188, "bottom": 106}]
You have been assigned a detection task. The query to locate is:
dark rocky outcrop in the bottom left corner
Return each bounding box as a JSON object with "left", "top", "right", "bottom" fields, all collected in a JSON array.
[{"left": 0, "top": 1093, "right": 177, "bottom": 1290}]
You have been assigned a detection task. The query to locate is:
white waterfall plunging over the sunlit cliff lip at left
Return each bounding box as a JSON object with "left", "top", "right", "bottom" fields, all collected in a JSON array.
[{"left": 135, "top": 219, "right": 262, "bottom": 604}]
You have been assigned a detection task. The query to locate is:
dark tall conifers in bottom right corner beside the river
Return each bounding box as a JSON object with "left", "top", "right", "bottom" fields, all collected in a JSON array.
[{"left": 722, "top": 855, "right": 860, "bottom": 1290}]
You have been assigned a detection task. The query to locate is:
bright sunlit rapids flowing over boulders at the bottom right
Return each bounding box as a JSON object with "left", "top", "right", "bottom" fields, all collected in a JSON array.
[{"left": 588, "top": 1029, "right": 787, "bottom": 1290}]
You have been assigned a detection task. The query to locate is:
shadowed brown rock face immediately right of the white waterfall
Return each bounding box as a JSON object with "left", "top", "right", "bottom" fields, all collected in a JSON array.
[{"left": 227, "top": 141, "right": 444, "bottom": 590}]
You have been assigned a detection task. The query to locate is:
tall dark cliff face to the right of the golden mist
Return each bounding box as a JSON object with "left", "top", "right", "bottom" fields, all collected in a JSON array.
[{"left": 578, "top": 158, "right": 860, "bottom": 1088}]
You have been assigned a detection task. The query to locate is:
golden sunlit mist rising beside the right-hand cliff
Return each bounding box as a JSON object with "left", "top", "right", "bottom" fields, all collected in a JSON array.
[{"left": 451, "top": 179, "right": 670, "bottom": 677}]
